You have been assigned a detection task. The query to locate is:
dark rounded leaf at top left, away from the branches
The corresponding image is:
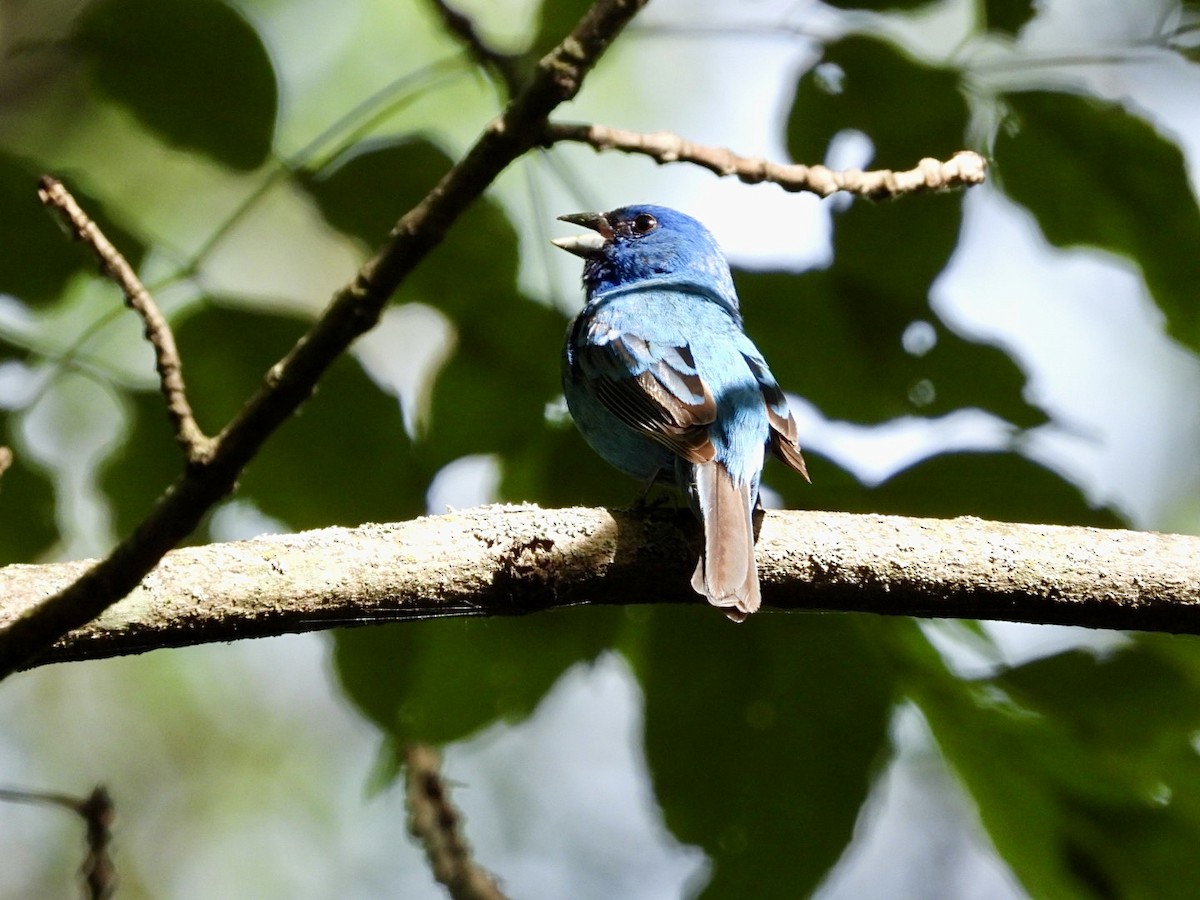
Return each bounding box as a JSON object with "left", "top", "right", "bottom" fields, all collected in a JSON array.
[{"left": 74, "top": 0, "right": 278, "bottom": 169}]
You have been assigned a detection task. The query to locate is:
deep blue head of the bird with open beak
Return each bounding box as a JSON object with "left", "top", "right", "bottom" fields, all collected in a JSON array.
[{"left": 553, "top": 205, "right": 738, "bottom": 310}]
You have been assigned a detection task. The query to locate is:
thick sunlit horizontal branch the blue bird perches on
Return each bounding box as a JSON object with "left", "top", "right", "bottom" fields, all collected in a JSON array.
[{"left": 0, "top": 506, "right": 1200, "bottom": 666}]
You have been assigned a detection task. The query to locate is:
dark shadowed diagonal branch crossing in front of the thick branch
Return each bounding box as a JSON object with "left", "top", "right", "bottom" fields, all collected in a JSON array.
[{"left": 0, "top": 0, "right": 648, "bottom": 678}]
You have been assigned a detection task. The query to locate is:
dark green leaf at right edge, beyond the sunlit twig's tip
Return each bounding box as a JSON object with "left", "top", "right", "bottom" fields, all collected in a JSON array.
[{"left": 995, "top": 91, "right": 1200, "bottom": 350}]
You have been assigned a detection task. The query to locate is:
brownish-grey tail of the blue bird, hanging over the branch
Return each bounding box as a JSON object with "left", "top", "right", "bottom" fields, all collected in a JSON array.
[{"left": 691, "top": 461, "right": 761, "bottom": 622}]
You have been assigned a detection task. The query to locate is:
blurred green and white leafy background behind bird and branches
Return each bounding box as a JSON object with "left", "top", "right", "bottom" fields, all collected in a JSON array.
[{"left": 0, "top": 0, "right": 1200, "bottom": 900}]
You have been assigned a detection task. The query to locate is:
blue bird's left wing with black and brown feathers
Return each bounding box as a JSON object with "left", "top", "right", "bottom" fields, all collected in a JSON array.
[{"left": 575, "top": 322, "right": 716, "bottom": 463}]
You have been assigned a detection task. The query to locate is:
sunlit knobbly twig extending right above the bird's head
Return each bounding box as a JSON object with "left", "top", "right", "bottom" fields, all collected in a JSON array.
[{"left": 544, "top": 122, "right": 988, "bottom": 199}]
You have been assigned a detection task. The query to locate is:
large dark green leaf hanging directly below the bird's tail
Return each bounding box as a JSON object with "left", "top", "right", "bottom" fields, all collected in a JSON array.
[{"left": 632, "top": 606, "right": 894, "bottom": 898}]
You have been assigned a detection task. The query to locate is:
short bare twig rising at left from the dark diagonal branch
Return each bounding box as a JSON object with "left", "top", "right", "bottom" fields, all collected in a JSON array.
[{"left": 37, "top": 175, "right": 212, "bottom": 464}]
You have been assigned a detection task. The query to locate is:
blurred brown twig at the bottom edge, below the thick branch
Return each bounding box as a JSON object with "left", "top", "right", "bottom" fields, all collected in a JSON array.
[{"left": 404, "top": 744, "right": 504, "bottom": 900}]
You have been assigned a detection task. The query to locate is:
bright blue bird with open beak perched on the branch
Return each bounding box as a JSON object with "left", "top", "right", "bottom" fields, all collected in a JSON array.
[{"left": 552, "top": 204, "right": 809, "bottom": 622}]
